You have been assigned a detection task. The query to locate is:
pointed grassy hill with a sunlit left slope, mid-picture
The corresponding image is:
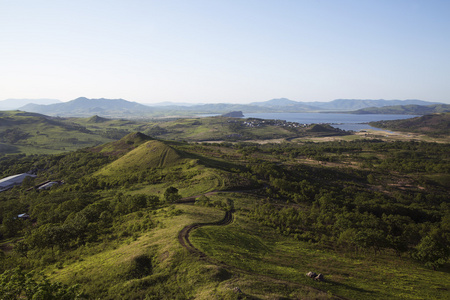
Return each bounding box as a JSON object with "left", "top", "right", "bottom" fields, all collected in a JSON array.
[{"left": 92, "top": 133, "right": 248, "bottom": 197}]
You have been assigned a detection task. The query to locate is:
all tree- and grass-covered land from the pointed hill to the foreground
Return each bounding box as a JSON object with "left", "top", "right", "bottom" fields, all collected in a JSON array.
[{"left": 0, "top": 118, "right": 450, "bottom": 299}]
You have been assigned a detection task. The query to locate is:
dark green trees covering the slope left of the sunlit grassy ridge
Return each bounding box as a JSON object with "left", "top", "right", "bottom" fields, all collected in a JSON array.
[{"left": 0, "top": 151, "right": 185, "bottom": 288}]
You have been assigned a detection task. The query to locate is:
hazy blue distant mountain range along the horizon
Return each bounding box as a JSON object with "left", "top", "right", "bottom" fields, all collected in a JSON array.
[{"left": 0, "top": 97, "right": 439, "bottom": 118}]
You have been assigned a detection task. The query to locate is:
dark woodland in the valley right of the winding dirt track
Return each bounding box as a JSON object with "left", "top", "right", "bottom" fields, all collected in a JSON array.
[{"left": 237, "top": 142, "right": 450, "bottom": 268}]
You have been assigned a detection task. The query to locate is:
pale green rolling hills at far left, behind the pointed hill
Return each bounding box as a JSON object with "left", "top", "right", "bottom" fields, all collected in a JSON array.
[{"left": 0, "top": 111, "right": 145, "bottom": 154}]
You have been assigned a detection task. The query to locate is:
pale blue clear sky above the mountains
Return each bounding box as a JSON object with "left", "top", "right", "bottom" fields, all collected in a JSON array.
[{"left": 0, "top": 0, "right": 450, "bottom": 103}]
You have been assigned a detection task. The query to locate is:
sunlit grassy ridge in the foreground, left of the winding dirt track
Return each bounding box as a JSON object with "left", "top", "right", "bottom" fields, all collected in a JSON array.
[{"left": 47, "top": 205, "right": 241, "bottom": 299}]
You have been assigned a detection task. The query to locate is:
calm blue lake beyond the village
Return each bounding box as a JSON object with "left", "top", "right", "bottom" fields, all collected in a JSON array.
[{"left": 244, "top": 113, "right": 417, "bottom": 131}]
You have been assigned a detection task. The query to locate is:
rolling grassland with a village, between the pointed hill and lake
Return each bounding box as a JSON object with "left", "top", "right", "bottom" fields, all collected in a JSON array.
[{"left": 0, "top": 111, "right": 350, "bottom": 154}]
